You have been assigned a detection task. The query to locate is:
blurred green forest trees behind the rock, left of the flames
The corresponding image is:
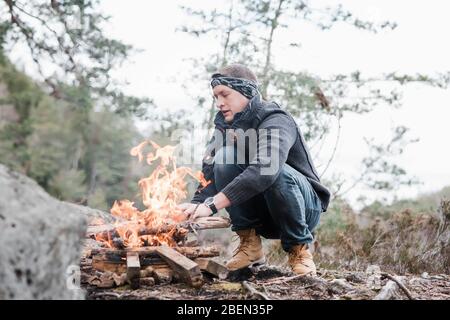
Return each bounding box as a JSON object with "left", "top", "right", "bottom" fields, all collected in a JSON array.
[{"left": 0, "top": 55, "right": 142, "bottom": 210}]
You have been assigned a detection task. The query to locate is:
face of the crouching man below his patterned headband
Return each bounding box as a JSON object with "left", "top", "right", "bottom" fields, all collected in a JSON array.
[{"left": 213, "top": 84, "right": 249, "bottom": 122}]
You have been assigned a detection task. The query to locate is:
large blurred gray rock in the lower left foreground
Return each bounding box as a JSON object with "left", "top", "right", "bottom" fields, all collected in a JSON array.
[{"left": 0, "top": 164, "right": 88, "bottom": 300}]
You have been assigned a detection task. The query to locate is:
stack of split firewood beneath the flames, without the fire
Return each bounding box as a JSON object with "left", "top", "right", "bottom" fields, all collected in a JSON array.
[{"left": 85, "top": 217, "right": 230, "bottom": 288}]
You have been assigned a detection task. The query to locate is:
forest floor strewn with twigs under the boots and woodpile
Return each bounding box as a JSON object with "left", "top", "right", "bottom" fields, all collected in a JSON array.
[{"left": 81, "top": 255, "right": 450, "bottom": 300}]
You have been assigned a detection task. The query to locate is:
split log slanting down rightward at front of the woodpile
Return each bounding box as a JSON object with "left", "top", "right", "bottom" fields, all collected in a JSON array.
[{"left": 157, "top": 246, "right": 203, "bottom": 287}]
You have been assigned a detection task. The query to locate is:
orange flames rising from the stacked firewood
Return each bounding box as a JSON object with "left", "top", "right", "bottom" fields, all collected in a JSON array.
[{"left": 96, "top": 140, "right": 211, "bottom": 248}]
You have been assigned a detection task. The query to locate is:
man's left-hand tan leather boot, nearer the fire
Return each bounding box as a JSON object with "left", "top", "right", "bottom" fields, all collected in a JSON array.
[{"left": 226, "top": 229, "right": 266, "bottom": 270}]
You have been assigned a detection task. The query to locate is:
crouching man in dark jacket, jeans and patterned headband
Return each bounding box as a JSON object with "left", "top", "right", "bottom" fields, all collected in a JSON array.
[{"left": 180, "top": 64, "right": 330, "bottom": 275}]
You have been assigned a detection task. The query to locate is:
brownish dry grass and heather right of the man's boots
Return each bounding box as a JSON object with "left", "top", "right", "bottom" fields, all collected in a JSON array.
[{"left": 316, "top": 201, "right": 450, "bottom": 274}]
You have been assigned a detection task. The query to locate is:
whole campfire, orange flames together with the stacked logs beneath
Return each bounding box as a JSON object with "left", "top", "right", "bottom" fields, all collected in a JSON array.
[{"left": 87, "top": 141, "right": 230, "bottom": 288}]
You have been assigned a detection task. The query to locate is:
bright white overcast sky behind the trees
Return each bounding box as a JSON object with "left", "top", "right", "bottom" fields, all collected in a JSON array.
[{"left": 11, "top": 0, "right": 450, "bottom": 208}]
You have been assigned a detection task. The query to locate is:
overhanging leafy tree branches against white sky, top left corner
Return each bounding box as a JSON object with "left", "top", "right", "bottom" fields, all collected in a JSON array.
[{"left": 0, "top": 0, "right": 153, "bottom": 116}]
